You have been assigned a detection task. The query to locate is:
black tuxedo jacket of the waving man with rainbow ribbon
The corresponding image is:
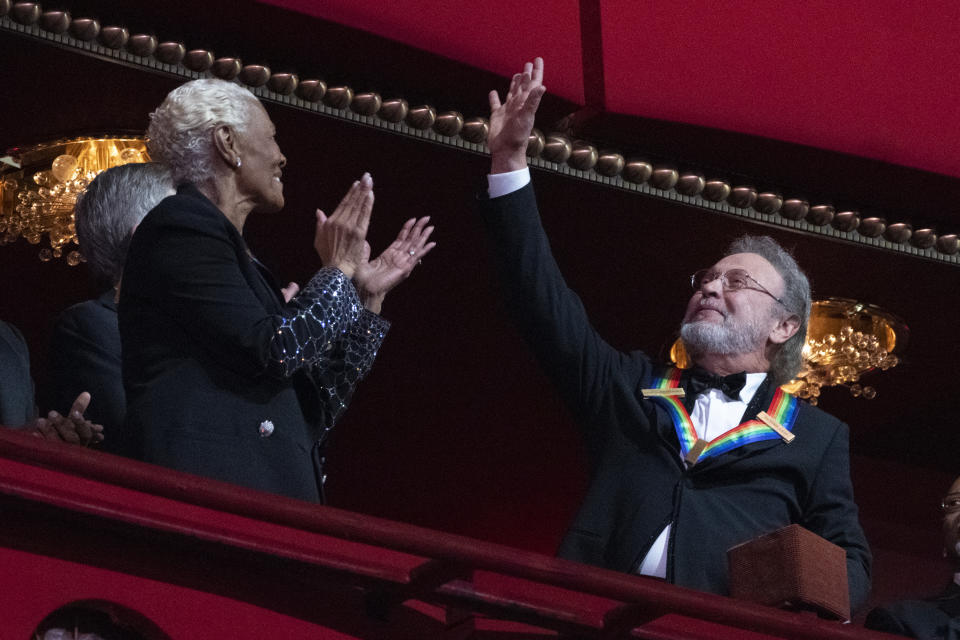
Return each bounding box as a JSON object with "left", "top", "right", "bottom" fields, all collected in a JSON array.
[{"left": 481, "top": 185, "right": 870, "bottom": 607}]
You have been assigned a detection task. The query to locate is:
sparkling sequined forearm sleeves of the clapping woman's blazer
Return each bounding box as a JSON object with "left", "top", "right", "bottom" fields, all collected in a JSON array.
[{"left": 268, "top": 267, "right": 389, "bottom": 378}]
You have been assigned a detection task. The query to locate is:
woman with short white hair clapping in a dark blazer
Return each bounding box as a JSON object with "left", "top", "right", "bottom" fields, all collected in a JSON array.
[{"left": 120, "top": 79, "right": 434, "bottom": 501}]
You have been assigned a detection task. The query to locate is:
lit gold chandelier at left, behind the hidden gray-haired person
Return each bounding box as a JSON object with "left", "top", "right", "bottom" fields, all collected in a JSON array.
[{"left": 0, "top": 136, "right": 150, "bottom": 266}]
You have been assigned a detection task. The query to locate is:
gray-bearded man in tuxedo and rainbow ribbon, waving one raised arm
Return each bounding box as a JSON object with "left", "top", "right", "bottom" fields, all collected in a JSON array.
[{"left": 481, "top": 58, "right": 871, "bottom": 609}]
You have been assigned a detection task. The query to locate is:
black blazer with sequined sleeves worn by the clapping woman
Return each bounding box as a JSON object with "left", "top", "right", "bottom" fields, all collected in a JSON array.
[{"left": 120, "top": 184, "right": 388, "bottom": 501}]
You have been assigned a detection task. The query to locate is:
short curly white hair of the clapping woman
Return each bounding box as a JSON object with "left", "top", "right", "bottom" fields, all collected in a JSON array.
[{"left": 147, "top": 78, "right": 257, "bottom": 185}]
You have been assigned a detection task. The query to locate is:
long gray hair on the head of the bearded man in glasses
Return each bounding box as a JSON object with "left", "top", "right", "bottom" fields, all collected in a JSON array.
[{"left": 724, "top": 236, "right": 811, "bottom": 385}]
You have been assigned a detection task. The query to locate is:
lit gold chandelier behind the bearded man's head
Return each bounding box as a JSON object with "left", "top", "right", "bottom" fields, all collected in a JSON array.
[{"left": 670, "top": 298, "right": 910, "bottom": 405}]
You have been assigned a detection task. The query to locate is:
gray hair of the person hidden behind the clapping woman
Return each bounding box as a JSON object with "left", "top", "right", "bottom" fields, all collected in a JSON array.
[{"left": 74, "top": 162, "right": 173, "bottom": 287}]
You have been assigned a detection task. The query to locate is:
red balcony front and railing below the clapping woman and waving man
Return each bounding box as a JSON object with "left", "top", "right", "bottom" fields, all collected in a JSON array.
[{"left": 0, "top": 429, "right": 889, "bottom": 640}]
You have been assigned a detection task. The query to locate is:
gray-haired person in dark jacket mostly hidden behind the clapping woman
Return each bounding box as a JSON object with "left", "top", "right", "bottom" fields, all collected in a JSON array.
[{"left": 45, "top": 162, "right": 176, "bottom": 453}]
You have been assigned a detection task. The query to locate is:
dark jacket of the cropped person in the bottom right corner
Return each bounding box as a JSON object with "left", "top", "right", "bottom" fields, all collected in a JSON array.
[{"left": 864, "top": 583, "right": 960, "bottom": 640}]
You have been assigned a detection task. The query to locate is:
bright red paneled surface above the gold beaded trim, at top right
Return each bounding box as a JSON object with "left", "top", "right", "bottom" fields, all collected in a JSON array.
[{"left": 262, "top": 0, "right": 960, "bottom": 176}]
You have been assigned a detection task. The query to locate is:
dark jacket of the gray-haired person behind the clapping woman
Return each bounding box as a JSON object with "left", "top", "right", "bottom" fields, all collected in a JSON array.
[{"left": 43, "top": 289, "right": 127, "bottom": 453}]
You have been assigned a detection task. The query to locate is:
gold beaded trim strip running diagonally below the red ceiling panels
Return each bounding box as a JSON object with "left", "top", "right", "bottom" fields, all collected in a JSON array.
[{"left": 0, "top": 13, "right": 960, "bottom": 266}]
